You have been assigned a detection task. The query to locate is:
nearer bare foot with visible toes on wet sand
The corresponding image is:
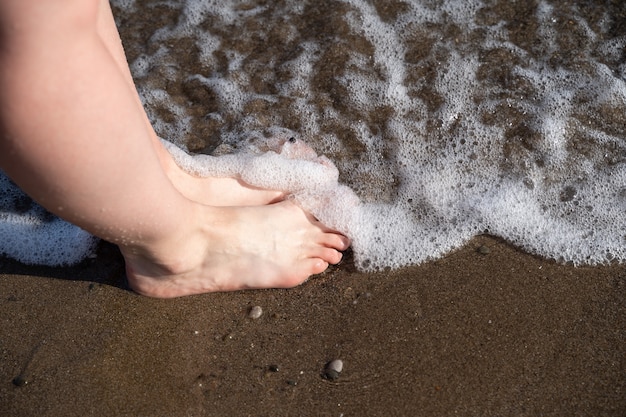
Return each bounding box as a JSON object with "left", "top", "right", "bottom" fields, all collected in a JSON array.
[{"left": 121, "top": 201, "right": 350, "bottom": 298}]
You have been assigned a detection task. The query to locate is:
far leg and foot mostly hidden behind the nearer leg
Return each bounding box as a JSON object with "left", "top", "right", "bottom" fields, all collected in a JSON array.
[{"left": 98, "top": 0, "right": 284, "bottom": 206}]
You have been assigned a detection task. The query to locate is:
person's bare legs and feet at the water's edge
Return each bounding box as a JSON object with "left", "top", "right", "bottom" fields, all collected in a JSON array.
[{"left": 0, "top": 0, "right": 349, "bottom": 297}]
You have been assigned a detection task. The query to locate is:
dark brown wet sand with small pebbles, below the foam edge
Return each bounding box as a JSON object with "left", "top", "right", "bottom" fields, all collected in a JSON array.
[{"left": 0, "top": 237, "right": 626, "bottom": 416}]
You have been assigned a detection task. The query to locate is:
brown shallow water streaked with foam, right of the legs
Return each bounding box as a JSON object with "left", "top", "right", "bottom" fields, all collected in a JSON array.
[{"left": 1, "top": 0, "right": 626, "bottom": 269}]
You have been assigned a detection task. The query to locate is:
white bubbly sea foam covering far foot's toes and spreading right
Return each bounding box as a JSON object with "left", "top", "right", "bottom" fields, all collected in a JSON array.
[{"left": 118, "top": 0, "right": 626, "bottom": 269}]
